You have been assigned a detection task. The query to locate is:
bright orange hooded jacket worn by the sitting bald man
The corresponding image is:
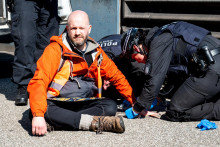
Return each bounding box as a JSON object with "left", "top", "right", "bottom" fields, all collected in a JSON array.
[{"left": 28, "top": 35, "right": 135, "bottom": 117}]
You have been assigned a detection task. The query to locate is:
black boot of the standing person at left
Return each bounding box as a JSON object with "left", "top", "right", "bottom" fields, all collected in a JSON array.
[{"left": 15, "top": 86, "right": 29, "bottom": 106}]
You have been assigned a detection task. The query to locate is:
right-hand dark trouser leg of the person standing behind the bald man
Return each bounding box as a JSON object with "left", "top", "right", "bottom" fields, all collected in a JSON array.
[{"left": 32, "top": 0, "right": 59, "bottom": 69}]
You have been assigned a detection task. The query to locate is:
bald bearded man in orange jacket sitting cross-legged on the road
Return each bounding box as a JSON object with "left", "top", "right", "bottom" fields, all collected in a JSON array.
[{"left": 28, "top": 10, "right": 134, "bottom": 135}]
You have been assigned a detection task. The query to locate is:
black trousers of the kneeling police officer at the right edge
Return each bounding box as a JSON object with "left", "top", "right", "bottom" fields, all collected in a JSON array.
[{"left": 168, "top": 36, "right": 220, "bottom": 121}]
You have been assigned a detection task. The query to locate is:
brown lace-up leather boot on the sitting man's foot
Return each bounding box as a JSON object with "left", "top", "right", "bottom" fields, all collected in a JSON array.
[{"left": 90, "top": 116, "right": 125, "bottom": 134}]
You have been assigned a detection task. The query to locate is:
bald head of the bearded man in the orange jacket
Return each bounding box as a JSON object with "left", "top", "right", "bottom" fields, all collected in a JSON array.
[{"left": 67, "top": 10, "right": 92, "bottom": 50}]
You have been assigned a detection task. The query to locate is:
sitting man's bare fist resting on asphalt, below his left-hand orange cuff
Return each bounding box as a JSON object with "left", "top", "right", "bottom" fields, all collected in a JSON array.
[{"left": 32, "top": 117, "right": 47, "bottom": 136}]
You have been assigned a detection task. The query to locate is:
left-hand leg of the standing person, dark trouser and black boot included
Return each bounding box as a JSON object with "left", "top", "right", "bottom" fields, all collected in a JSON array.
[{"left": 12, "top": 0, "right": 38, "bottom": 105}]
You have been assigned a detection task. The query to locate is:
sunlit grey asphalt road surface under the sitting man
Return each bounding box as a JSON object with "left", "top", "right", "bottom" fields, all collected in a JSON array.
[{"left": 0, "top": 44, "right": 220, "bottom": 147}]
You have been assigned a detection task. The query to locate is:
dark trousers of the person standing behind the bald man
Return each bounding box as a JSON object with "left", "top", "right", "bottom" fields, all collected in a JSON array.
[{"left": 11, "top": 0, "right": 59, "bottom": 86}]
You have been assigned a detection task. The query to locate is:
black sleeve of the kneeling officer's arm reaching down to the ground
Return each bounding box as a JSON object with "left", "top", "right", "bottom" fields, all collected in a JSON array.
[{"left": 134, "top": 32, "right": 174, "bottom": 112}]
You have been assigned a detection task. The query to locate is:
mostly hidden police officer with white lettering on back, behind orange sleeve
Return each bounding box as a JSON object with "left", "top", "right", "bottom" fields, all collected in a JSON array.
[{"left": 98, "top": 34, "right": 145, "bottom": 104}]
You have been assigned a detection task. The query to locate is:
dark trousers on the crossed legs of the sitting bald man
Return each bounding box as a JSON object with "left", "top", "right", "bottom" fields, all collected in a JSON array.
[{"left": 44, "top": 98, "right": 117, "bottom": 130}]
